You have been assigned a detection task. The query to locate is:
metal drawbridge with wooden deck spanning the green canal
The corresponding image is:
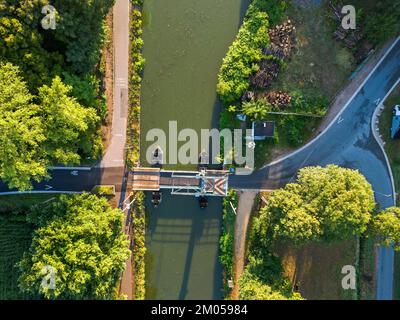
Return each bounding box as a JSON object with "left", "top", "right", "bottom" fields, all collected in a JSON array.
[{"left": 132, "top": 168, "right": 229, "bottom": 197}]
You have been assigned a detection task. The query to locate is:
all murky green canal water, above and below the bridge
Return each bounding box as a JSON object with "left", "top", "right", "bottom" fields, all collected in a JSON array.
[{"left": 141, "top": 0, "right": 248, "bottom": 299}]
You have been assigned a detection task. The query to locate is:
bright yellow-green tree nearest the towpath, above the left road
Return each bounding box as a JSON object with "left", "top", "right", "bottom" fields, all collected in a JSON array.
[{"left": 39, "top": 77, "right": 100, "bottom": 165}]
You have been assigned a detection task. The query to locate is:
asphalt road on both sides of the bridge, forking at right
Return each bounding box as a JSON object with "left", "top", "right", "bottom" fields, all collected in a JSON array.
[{"left": 0, "top": 33, "right": 400, "bottom": 299}]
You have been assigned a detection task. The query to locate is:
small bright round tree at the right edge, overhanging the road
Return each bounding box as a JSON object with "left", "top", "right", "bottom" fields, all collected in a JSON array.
[{"left": 371, "top": 207, "right": 400, "bottom": 251}]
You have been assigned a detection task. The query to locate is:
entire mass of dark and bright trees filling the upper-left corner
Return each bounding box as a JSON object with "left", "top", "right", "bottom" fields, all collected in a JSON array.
[{"left": 0, "top": 0, "right": 114, "bottom": 190}]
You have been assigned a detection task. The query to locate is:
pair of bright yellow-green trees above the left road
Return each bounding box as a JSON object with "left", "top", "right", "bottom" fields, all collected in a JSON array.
[{"left": 0, "top": 63, "right": 100, "bottom": 190}]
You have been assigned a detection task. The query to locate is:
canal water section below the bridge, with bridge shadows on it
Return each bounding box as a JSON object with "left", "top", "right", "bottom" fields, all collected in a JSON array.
[{"left": 146, "top": 192, "right": 222, "bottom": 299}]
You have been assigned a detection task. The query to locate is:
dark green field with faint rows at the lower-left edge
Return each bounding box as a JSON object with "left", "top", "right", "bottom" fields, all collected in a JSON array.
[{"left": 0, "top": 194, "right": 54, "bottom": 300}]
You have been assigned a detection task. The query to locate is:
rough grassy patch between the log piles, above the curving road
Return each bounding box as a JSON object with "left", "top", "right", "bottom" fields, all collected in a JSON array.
[{"left": 273, "top": 1, "right": 354, "bottom": 99}]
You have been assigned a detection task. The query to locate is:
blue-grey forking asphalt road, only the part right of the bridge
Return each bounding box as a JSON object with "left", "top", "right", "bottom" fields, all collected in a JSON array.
[{"left": 229, "top": 36, "right": 400, "bottom": 299}]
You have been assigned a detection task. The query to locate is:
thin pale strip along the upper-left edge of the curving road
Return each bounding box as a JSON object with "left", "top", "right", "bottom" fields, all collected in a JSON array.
[{"left": 261, "top": 36, "right": 400, "bottom": 169}]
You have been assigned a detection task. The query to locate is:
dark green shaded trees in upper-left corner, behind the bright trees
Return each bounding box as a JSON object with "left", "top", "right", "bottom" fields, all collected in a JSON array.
[{"left": 0, "top": 0, "right": 114, "bottom": 90}]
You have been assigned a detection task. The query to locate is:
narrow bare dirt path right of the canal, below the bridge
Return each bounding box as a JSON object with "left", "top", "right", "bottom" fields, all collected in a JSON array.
[{"left": 232, "top": 190, "right": 258, "bottom": 300}]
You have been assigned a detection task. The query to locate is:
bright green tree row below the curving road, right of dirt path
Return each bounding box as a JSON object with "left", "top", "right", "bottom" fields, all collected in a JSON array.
[{"left": 239, "top": 165, "right": 400, "bottom": 299}]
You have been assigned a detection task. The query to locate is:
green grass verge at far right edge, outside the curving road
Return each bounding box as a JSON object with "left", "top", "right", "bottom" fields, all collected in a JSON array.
[{"left": 379, "top": 86, "right": 400, "bottom": 300}]
